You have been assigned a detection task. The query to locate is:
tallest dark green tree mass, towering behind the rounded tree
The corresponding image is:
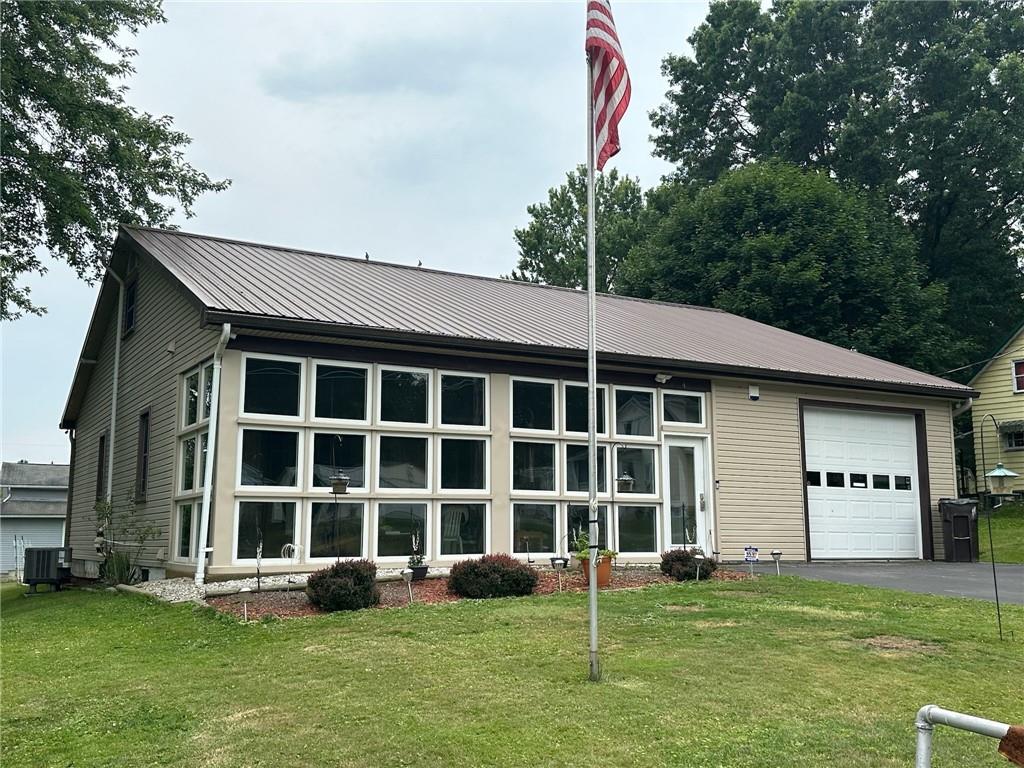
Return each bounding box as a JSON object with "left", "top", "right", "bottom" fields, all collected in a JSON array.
[{"left": 651, "top": 0, "right": 1024, "bottom": 370}]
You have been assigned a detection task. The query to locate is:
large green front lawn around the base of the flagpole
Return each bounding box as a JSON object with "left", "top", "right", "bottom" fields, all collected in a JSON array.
[{"left": 0, "top": 578, "right": 1024, "bottom": 768}]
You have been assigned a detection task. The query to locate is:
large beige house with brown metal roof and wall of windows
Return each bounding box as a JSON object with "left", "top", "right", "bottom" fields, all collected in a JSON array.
[{"left": 61, "top": 226, "right": 974, "bottom": 579}]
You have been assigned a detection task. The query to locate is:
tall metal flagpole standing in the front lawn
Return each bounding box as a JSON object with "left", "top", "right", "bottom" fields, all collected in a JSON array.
[{"left": 587, "top": 56, "right": 598, "bottom": 682}]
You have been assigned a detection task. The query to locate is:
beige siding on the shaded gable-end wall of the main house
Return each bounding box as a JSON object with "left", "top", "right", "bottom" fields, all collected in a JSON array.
[{"left": 70, "top": 257, "right": 218, "bottom": 573}]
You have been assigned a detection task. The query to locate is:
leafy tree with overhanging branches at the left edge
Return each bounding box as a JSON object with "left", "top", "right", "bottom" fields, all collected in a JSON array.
[{"left": 0, "top": 0, "right": 228, "bottom": 319}]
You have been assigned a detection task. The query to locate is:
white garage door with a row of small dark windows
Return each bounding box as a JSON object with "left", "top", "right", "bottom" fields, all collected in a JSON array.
[{"left": 804, "top": 408, "right": 922, "bottom": 559}]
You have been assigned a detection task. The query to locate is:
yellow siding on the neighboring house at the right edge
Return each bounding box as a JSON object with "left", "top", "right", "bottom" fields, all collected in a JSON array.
[{"left": 971, "top": 331, "right": 1024, "bottom": 490}]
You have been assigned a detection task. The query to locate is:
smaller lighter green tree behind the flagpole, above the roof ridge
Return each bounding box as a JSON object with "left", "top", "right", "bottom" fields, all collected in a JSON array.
[{"left": 511, "top": 166, "right": 644, "bottom": 292}]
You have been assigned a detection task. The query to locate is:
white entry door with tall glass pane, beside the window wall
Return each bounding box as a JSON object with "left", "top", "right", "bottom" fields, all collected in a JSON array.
[{"left": 663, "top": 437, "right": 713, "bottom": 554}]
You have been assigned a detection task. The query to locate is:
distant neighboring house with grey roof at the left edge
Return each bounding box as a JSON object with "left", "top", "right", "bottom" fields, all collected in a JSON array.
[{"left": 0, "top": 461, "right": 69, "bottom": 577}]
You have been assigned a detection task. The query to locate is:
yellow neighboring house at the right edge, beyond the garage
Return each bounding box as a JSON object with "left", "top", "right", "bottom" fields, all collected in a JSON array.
[{"left": 971, "top": 326, "right": 1024, "bottom": 492}]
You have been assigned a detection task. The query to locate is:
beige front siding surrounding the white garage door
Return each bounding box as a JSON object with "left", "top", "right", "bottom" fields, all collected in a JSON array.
[{"left": 712, "top": 380, "right": 956, "bottom": 560}]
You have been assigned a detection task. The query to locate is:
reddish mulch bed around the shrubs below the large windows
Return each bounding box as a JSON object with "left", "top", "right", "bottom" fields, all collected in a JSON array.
[{"left": 207, "top": 568, "right": 750, "bottom": 622}]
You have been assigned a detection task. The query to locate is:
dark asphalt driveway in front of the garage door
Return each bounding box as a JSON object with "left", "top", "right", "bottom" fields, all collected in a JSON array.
[{"left": 749, "top": 561, "right": 1024, "bottom": 605}]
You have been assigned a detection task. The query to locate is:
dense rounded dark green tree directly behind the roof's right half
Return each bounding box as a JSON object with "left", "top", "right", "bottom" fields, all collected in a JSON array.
[{"left": 620, "top": 162, "right": 958, "bottom": 370}]
